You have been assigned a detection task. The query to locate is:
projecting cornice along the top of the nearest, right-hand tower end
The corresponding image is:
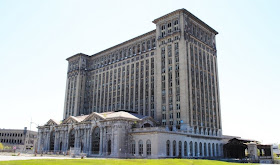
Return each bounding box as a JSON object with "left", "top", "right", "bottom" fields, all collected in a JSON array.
[{"left": 153, "top": 8, "right": 218, "bottom": 35}]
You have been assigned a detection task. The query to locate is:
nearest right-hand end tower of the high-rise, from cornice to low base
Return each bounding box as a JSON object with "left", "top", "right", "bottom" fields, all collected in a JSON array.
[{"left": 153, "top": 9, "right": 222, "bottom": 135}]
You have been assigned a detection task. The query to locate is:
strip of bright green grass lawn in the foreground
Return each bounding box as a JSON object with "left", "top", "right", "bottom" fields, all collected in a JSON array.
[{"left": 0, "top": 159, "right": 256, "bottom": 165}]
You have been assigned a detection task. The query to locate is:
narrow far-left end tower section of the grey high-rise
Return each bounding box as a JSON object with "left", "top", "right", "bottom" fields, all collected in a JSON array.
[{"left": 63, "top": 53, "right": 88, "bottom": 119}]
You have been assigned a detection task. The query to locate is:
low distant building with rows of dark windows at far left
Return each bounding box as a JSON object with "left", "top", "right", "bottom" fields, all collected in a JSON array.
[{"left": 0, "top": 127, "right": 37, "bottom": 152}]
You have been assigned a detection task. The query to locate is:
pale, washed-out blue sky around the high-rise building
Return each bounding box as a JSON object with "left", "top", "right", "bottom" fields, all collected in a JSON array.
[{"left": 0, "top": 0, "right": 280, "bottom": 143}]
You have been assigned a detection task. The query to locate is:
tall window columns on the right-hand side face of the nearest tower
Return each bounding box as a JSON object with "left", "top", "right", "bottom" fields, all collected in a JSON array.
[{"left": 189, "top": 44, "right": 220, "bottom": 128}]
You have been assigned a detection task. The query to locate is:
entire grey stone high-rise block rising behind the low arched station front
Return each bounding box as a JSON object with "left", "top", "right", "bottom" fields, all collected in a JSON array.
[{"left": 64, "top": 9, "right": 221, "bottom": 135}]
